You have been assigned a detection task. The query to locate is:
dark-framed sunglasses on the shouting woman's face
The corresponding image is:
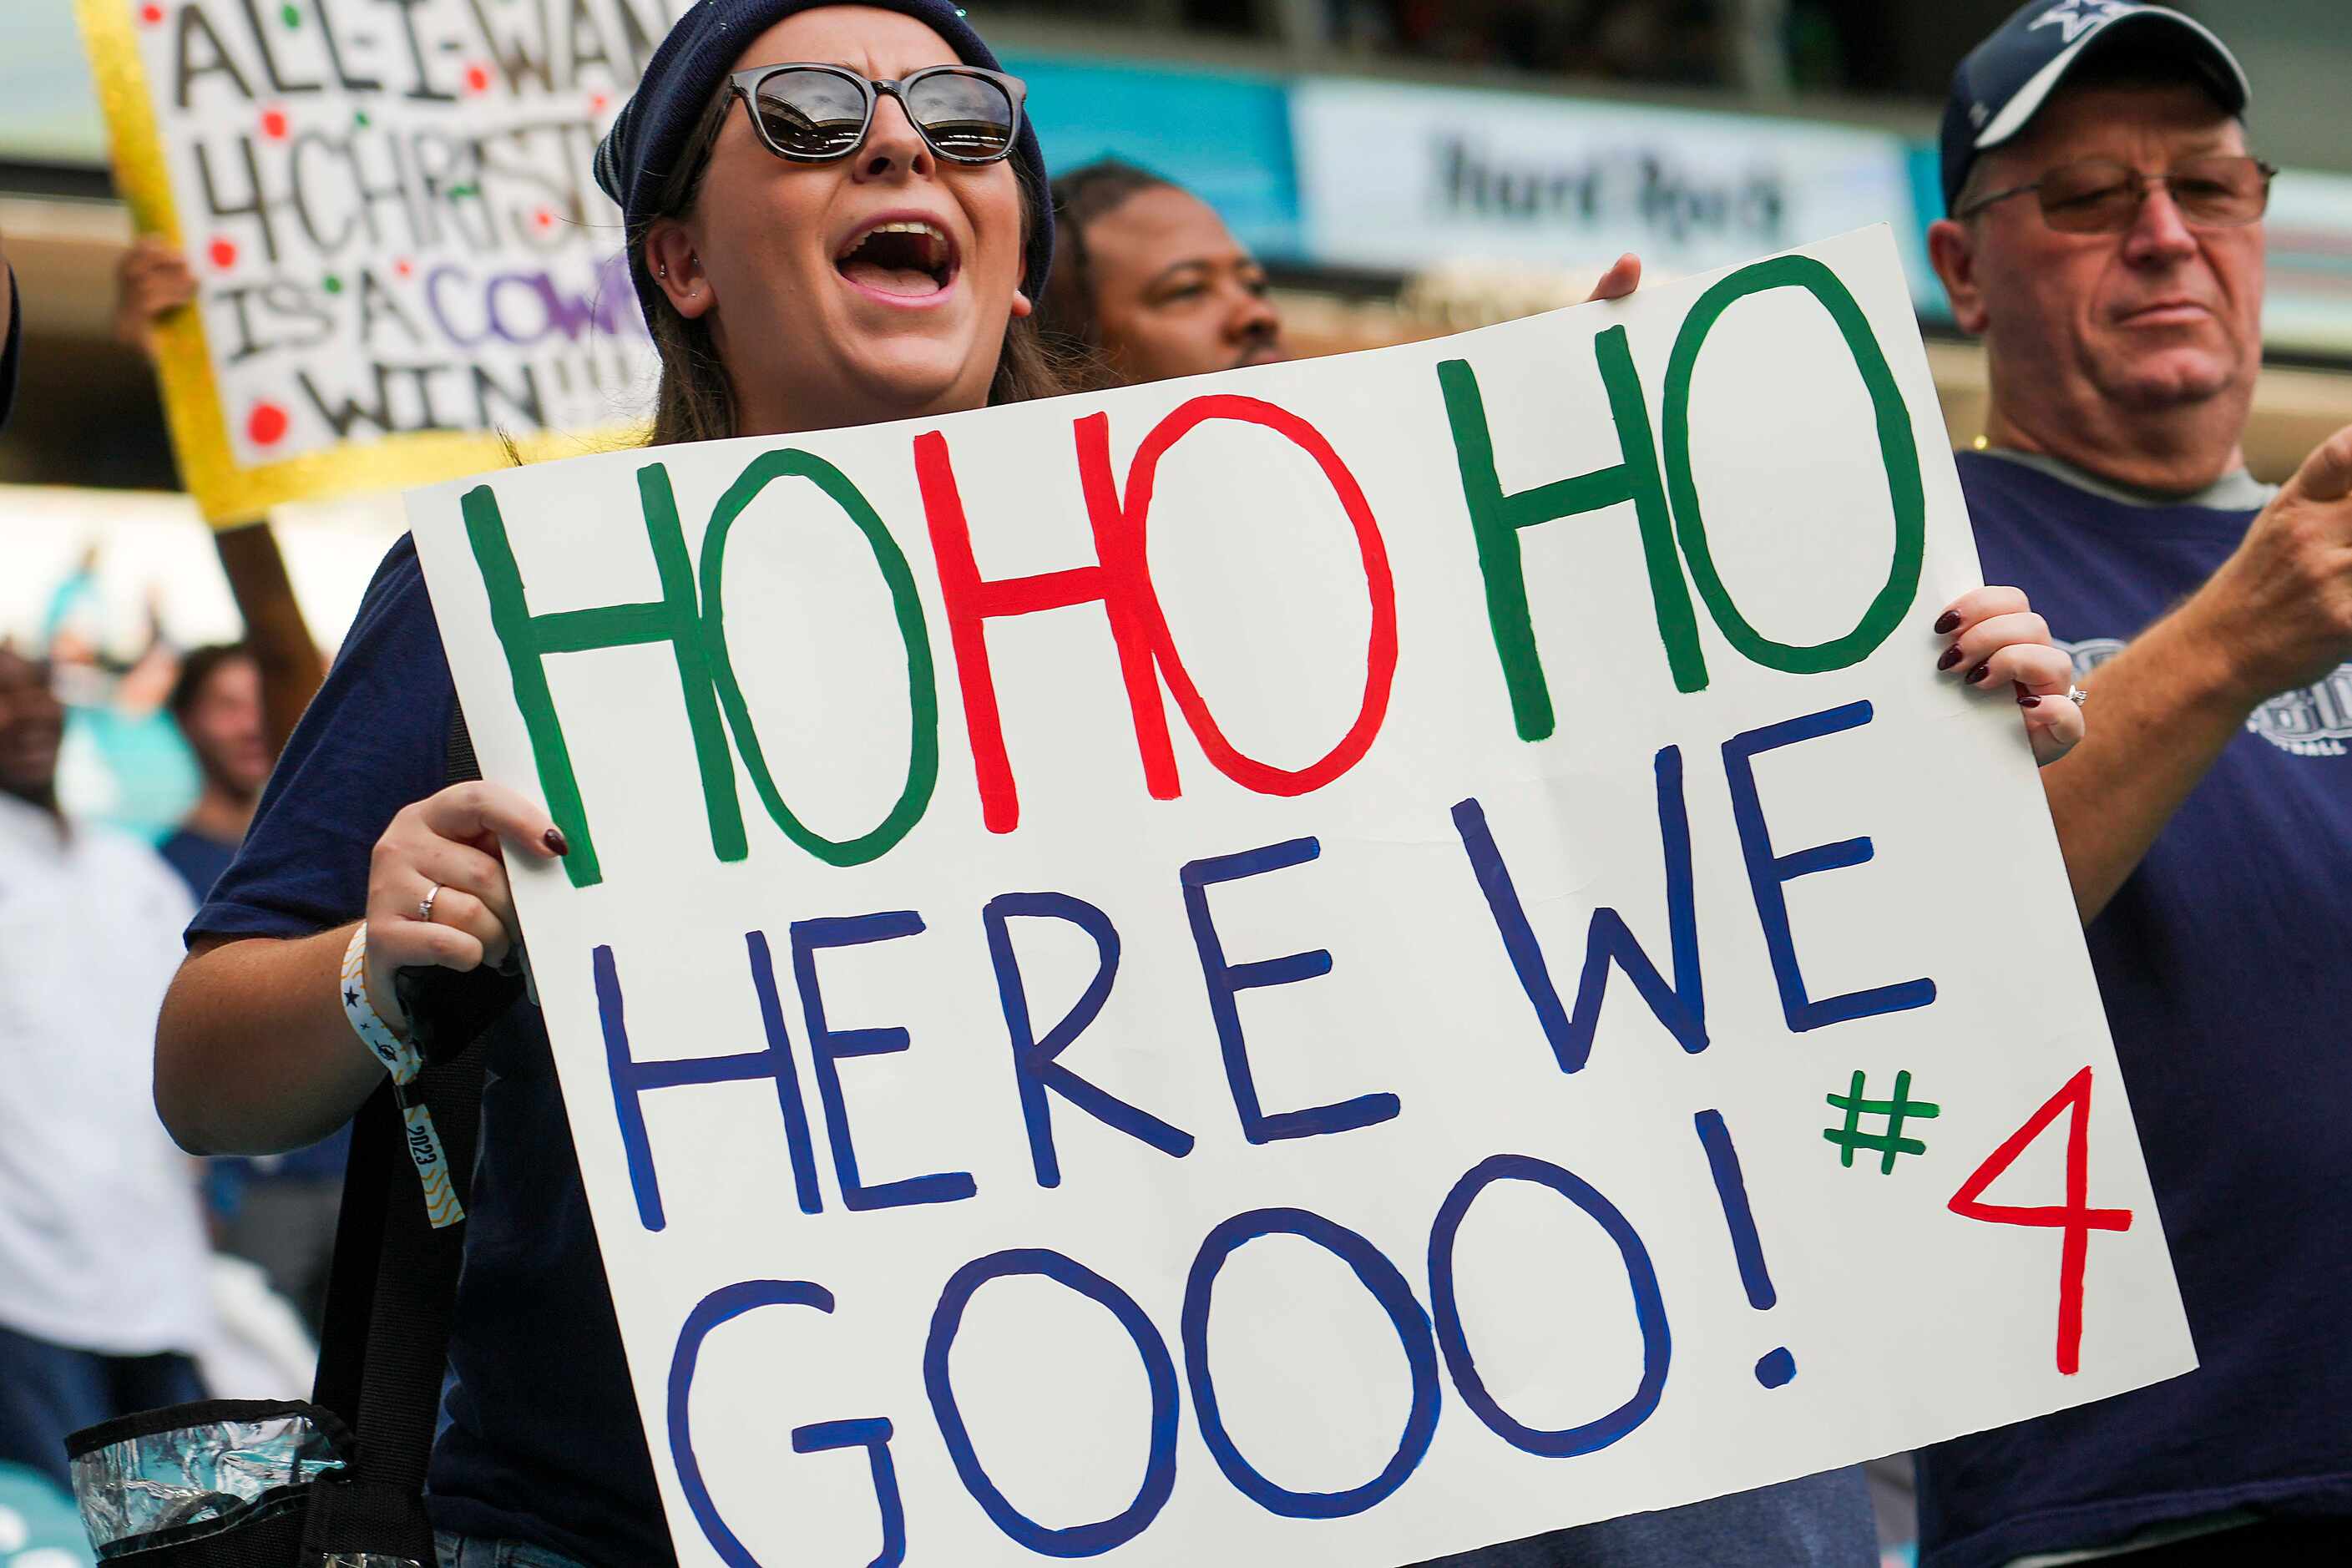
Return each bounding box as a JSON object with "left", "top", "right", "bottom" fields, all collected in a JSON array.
[{"left": 726, "top": 66, "right": 1028, "bottom": 162}]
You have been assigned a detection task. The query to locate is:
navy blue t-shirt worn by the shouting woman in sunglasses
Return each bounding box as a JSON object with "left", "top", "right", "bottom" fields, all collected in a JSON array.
[{"left": 188, "top": 539, "right": 675, "bottom": 1568}]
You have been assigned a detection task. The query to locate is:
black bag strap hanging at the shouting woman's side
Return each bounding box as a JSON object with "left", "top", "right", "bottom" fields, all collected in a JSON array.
[{"left": 303, "top": 706, "right": 482, "bottom": 1563}]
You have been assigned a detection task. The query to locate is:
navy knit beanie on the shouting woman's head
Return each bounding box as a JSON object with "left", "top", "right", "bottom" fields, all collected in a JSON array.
[{"left": 595, "top": 0, "right": 1054, "bottom": 325}]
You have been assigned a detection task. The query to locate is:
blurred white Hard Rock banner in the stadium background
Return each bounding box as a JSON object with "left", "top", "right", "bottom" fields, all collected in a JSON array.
[{"left": 1292, "top": 80, "right": 1931, "bottom": 277}]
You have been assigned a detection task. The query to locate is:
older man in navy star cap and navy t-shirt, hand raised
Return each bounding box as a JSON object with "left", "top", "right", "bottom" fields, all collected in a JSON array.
[{"left": 1920, "top": 0, "right": 2352, "bottom": 1568}]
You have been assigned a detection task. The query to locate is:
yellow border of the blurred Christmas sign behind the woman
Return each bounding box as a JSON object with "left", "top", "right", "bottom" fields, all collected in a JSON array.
[{"left": 73, "top": 0, "right": 645, "bottom": 529}]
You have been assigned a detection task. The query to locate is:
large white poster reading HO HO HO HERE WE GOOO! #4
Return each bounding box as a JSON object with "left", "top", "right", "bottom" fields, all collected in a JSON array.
[{"left": 412, "top": 230, "right": 2192, "bottom": 1568}]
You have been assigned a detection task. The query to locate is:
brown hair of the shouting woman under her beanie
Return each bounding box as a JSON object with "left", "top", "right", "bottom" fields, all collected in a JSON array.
[{"left": 628, "top": 87, "right": 1073, "bottom": 447}]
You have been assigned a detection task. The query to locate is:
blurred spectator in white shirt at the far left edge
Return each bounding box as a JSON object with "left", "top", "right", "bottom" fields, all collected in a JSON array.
[{"left": 0, "top": 644, "right": 210, "bottom": 1481}]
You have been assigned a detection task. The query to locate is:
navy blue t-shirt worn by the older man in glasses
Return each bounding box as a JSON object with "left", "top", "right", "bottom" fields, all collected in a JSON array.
[{"left": 1920, "top": 453, "right": 2352, "bottom": 1568}]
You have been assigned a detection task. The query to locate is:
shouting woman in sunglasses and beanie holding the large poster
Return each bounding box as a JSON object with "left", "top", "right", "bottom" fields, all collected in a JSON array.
[{"left": 155, "top": 0, "right": 2081, "bottom": 1568}]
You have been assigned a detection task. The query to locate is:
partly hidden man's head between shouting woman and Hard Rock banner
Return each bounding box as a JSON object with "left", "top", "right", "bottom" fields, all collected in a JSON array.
[{"left": 1039, "top": 158, "right": 1289, "bottom": 383}]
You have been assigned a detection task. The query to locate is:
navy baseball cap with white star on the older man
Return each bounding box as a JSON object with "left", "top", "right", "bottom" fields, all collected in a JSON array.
[{"left": 1943, "top": 0, "right": 2253, "bottom": 211}]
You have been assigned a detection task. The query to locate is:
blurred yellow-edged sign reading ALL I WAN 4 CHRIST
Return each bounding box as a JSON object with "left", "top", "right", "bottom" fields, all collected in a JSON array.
[{"left": 75, "top": 0, "right": 689, "bottom": 524}]
